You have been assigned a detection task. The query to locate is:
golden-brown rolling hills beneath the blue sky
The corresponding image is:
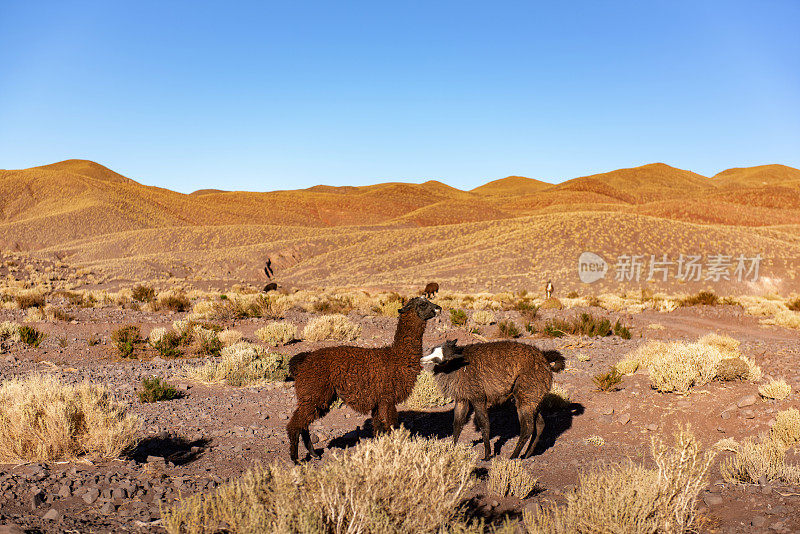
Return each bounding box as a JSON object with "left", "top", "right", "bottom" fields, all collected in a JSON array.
[{"left": 0, "top": 160, "right": 800, "bottom": 290}]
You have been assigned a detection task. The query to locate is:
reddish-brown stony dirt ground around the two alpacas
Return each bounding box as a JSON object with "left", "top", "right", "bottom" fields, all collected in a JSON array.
[{"left": 0, "top": 300, "right": 800, "bottom": 532}]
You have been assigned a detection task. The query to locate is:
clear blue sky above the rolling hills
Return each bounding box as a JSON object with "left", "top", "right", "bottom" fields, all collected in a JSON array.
[{"left": 0, "top": 0, "right": 800, "bottom": 192}]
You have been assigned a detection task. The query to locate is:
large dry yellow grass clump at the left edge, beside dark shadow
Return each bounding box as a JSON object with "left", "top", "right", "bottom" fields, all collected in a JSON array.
[{"left": 0, "top": 375, "right": 139, "bottom": 462}]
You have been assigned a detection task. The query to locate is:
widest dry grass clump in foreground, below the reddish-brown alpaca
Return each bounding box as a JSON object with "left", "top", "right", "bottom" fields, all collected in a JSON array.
[{"left": 163, "top": 430, "right": 476, "bottom": 534}]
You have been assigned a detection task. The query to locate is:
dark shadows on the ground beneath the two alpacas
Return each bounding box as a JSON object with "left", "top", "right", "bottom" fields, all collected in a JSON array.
[{"left": 328, "top": 400, "right": 584, "bottom": 455}]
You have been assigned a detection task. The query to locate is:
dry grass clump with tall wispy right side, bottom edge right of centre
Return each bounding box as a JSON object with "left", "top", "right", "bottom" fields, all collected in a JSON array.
[{"left": 523, "top": 431, "right": 716, "bottom": 534}]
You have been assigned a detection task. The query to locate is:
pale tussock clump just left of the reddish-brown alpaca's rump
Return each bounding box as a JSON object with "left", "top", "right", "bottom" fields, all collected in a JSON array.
[{"left": 186, "top": 341, "right": 289, "bottom": 386}]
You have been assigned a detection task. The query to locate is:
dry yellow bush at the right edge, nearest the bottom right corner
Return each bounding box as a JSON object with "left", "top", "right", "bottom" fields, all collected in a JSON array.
[{"left": 720, "top": 436, "right": 800, "bottom": 484}]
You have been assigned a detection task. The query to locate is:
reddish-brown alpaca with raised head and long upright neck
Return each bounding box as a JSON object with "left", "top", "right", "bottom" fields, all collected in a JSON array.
[{"left": 286, "top": 297, "right": 442, "bottom": 463}]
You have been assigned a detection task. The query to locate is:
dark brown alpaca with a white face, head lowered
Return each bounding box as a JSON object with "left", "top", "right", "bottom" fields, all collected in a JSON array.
[{"left": 421, "top": 340, "right": 564, "bottom": 460}]
